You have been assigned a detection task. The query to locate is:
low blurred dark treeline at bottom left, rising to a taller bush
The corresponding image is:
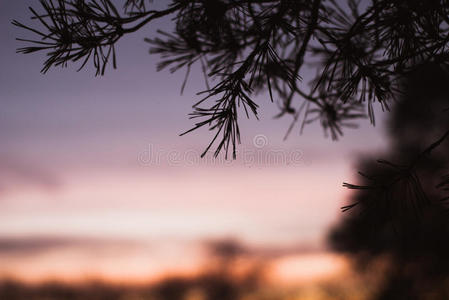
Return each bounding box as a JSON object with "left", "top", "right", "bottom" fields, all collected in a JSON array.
[{"left": 0, "top": 239, "right": 264, "bottom": 300}]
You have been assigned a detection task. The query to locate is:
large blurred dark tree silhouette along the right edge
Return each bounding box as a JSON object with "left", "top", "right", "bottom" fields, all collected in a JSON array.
[{"left": 330, "top": 64, "right": 449, "bottom": 300}]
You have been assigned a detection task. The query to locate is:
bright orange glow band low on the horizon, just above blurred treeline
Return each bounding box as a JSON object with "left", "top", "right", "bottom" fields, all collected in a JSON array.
[{"left": 0, "top": 251, "right": 347, "bottom": 285}]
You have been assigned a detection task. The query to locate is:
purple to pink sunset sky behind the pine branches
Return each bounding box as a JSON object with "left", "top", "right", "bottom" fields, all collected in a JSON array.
[{"left": 0, "top": 1, "right": 386, "bottom": 280}]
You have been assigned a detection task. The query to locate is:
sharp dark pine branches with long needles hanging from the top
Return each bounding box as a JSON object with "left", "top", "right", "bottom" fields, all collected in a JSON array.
[{"left": 13, "top": 0, "right": 449, "bottom": 157}]
